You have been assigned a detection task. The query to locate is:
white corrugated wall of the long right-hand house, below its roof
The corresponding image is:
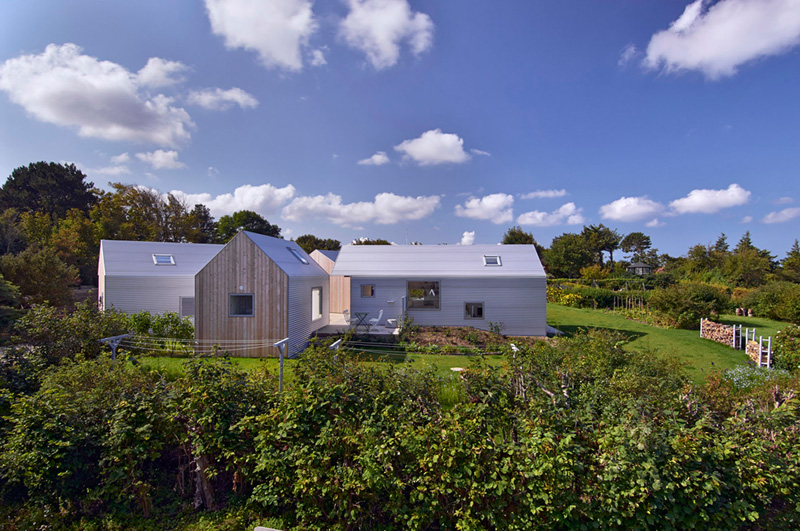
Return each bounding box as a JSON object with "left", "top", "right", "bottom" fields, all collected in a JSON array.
[{"left": 350, "top": 277, "right": 547, "bottom": 336}]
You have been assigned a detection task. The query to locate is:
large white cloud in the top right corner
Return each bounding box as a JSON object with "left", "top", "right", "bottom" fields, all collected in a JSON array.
[{"left": 644, "top": 0, "right": 800, "bottom": 79}]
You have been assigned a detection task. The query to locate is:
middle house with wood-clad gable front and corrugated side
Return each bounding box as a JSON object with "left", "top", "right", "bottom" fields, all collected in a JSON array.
[{"left": 194, "top": 231, "right": 330, "bottom": 357}]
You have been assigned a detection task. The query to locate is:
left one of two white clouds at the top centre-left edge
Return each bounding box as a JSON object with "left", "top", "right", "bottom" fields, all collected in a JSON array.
[{"left": 206, "top": 0, "right": 317, "bottom": 71}]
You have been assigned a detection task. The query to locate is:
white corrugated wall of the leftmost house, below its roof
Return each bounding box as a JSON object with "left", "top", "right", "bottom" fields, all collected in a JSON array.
[{"left": 103, "top": 276, "right": 194, "bottom": 314}]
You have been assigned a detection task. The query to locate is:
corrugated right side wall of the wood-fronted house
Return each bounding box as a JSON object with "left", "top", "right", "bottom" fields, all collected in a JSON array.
[{"left": 288, "top": 275, "right": 330, "bottom": 356}]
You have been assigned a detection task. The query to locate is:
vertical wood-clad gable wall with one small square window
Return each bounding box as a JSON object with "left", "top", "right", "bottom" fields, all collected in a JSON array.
[{"left": 195, "top": 233, "right": 289, "bottom": 357}]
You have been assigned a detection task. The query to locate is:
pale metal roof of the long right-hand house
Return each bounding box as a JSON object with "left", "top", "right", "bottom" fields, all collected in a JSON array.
[{"left": 331, "top": 245, "right": 545, "bottom": 278}]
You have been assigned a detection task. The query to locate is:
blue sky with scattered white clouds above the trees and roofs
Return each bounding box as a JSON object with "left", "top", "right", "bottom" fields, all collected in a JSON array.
[{"left": 0, "top": 0, "right": 800, "bottom": 257}]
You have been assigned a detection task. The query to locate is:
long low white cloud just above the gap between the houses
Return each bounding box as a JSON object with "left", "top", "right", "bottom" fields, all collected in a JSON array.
[{"left": 281, "top": 192, "right": 441, "bottom": 227}]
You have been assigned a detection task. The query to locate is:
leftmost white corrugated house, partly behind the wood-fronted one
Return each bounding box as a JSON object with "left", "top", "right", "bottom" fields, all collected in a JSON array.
[{"left": 97, "top": 240, "right": 223, "bottom": 317}]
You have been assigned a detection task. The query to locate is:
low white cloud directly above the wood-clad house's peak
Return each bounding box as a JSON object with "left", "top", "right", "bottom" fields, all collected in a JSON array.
[{"left": 170, "top": 184, "right": 295, "bottom": 218}]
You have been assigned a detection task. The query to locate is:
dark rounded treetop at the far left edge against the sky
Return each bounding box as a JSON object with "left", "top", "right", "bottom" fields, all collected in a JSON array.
[{"left": 0, "top": 162, "right": 97, "bottom": 220}]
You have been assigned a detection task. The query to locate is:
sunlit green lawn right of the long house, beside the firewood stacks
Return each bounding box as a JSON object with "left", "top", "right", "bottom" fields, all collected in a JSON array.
[{"left": 547, "top": 304, "right": 786, "bottom": 382}]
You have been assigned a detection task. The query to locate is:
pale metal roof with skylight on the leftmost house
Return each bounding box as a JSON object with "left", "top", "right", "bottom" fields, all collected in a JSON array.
[{"left": 100, "top": 240, "right": 223, "bottom": 277}]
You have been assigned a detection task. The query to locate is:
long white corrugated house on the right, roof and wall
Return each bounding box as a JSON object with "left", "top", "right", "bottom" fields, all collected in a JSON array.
[{"left": 332, "top": 245, "right": 547, "bottom": 336}]
